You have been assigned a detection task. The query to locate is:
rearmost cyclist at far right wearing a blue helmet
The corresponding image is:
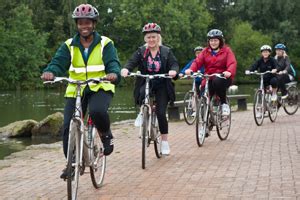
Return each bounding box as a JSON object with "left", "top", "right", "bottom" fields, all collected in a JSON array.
[{"left": 274, "top": 43, "right": 295, "bottom": 99}]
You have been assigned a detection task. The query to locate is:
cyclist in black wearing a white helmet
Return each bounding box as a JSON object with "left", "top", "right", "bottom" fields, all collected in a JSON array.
[{"left": 246, "top": 45, "right": 280, "bottom": 101}]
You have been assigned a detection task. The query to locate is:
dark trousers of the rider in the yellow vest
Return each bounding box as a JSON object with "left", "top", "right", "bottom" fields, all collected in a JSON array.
[{"left": 63, "top": 86, "right": 113, "bottom": 158}]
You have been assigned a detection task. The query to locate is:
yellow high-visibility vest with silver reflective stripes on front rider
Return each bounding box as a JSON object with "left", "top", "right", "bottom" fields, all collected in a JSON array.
[{"left": 65, "top": 36, "right": 115, "bottom": 97}]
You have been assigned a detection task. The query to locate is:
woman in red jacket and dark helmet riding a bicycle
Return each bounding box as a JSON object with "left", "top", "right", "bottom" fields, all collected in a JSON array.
[{"left": 185, "top": 29, "right": 237, "bottom": 115}]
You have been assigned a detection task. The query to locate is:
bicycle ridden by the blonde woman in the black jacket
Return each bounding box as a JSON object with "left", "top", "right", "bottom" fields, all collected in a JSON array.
[{"left": 128, "top": 71, "right": 171, "bottom": 169}]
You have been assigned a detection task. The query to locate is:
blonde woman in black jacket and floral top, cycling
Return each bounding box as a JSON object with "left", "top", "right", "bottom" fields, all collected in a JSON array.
[{"left": 121, "top": 23, "right": 179, "bottom": 155}]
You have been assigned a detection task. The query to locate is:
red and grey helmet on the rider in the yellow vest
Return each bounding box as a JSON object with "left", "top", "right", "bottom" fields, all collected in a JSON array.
[{"left": 72, "top": 4, "right": 99, "bottom": 20}]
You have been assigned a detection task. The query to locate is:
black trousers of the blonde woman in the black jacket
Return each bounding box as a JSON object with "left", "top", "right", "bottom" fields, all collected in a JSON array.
[{"left": 139, "top": 82, "right": 169, "bottom": 134}]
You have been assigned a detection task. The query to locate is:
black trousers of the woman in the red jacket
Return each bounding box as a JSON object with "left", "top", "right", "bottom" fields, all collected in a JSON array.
[{"left": 208, "top": 77, "right": 232, "bottom": 104}]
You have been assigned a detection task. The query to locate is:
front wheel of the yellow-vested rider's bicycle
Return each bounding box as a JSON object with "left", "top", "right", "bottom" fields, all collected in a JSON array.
[{"left": 67, "top": 120, "right": 80, "bottom": 200}]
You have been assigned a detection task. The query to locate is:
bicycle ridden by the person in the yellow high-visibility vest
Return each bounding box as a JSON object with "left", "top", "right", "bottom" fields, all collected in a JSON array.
[{"left": 44, "top": 77, "right": 108, "bottom": 200}]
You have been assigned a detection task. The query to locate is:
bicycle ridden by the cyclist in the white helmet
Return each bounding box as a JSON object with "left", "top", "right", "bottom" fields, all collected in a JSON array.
[{"left": 245, "top": 71, "right": 278, "bottom": 126}]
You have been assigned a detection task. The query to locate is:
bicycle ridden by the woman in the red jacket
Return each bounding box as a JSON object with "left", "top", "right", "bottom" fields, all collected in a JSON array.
[{"left": 193, "top": 73, "right": 231, "bottom": 147}]
